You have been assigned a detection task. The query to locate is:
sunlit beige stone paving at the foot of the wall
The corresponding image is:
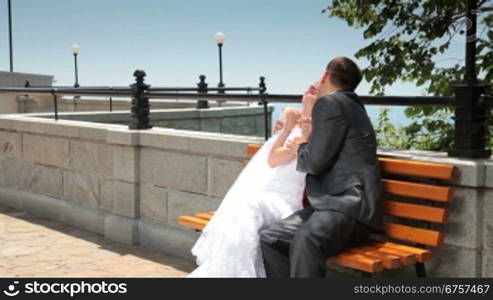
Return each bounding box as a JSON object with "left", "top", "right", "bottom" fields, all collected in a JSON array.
[{"left": 0, "top": 205, "right": 194, "bottom": 277}]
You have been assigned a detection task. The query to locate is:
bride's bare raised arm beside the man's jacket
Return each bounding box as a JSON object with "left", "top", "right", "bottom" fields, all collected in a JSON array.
[{"left": 268, "top": 108, "right": 301, "bottom": 168}]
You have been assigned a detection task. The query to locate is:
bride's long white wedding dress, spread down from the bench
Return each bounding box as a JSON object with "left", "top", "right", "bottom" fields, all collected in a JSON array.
[{"left": 188, "top": 127, "right": 305, "bottom": 277}]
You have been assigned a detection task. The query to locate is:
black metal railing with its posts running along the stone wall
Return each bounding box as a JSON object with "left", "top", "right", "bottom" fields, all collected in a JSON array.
[{"left": 0, "top": 70, "right": 493, "bottom": 158}]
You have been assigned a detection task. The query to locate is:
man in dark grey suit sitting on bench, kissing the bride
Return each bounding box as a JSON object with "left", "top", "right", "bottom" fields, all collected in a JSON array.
[{"left": 260, "top": 57, "right": 383, "bottom": 278}]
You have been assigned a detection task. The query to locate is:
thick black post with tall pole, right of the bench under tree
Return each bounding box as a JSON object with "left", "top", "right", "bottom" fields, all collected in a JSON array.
[{"left": 449, "top": 0, "right": 491, "bottom": 158}]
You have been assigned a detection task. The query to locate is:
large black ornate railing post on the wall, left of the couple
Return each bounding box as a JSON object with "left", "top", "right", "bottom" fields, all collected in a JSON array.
[{"left": 128, "top": 70, "right": 152, "bottom": 130}]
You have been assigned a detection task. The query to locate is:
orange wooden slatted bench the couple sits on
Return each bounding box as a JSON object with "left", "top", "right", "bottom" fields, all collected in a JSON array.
[{"left": 178, "top": 144, "right": 455, "bottom": 277}]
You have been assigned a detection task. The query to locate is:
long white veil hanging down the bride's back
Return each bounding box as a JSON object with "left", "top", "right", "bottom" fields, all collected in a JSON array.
[{"left": 192, "top": 129, "right": 279, "bottom": 265}]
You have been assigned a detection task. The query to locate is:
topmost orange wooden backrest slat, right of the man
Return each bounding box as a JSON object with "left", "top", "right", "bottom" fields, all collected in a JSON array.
[{"left": 379, "top": 157, "right": 455, "bottom": 180}]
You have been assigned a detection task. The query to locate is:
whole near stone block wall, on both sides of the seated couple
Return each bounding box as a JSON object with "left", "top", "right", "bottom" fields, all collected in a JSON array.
[{"left": 0, "top": 115, "right": 493, "bottom": 277}]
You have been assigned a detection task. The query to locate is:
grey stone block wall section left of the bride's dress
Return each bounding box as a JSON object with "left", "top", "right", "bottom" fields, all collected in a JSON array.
[{"left": 0, "top": 115, "right": 261, "bottom": 258}]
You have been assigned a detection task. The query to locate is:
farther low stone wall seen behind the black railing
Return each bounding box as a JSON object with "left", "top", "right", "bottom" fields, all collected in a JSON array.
[{"left": 38, "top": 105, "right": 274, "bottom": 136}]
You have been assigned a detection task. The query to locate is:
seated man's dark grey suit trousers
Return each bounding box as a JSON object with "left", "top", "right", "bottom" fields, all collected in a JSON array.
[{"left": 260, "top": 206, "right": 372, "bottom": 278}]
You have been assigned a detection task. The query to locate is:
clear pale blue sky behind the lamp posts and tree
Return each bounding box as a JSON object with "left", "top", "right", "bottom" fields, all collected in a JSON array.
[{"left": 0, "top": 0, "right": 463, "bottom": 123}]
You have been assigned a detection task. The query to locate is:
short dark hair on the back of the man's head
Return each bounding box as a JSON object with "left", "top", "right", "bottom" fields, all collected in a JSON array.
[{"left": 327, "top": 56, "right": 363, "bottom": 91}]
